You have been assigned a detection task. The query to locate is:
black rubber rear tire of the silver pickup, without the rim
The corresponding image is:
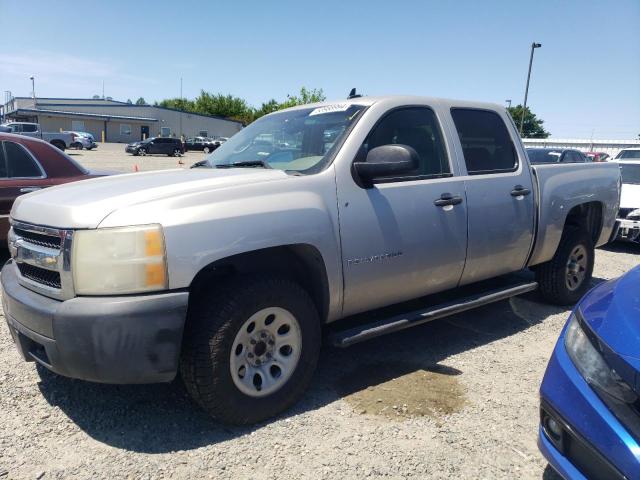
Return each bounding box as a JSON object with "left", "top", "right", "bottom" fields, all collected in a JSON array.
[{"left": 535, "top": 226, "right": 595, "bottom": 305}]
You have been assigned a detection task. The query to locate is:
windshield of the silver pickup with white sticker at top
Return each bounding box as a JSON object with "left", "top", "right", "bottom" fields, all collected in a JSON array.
[{"left": 204, "top": 103, "right": 365, "bottom": 174}]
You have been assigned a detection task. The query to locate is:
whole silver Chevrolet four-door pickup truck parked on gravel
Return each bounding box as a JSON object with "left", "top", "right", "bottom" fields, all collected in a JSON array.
[{"left": 2, "top": 97, "right": 620, "bottom": 424}]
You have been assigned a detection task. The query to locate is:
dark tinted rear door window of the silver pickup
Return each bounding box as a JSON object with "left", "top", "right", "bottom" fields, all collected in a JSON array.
[{"left": 451, "top": 108, "right": 518, "bottom": 175}]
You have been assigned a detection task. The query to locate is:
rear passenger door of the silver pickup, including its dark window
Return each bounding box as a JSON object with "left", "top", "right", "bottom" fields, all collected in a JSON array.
[{"left": 451, "top": 108, "right": 535, "bottom": 284}]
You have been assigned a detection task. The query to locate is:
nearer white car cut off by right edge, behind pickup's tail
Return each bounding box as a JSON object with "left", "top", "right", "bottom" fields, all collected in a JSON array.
[{"left": 617, "top": 161, "right": 640, "bottom": 243}]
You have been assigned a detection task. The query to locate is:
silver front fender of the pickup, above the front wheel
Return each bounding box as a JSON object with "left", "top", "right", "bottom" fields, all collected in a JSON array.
[{"left": 100, "top": 171, "right": 342, "bottom": 317}]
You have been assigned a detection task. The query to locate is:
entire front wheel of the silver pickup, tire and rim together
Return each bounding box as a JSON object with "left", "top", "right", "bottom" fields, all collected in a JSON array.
[{"left": 180, "top": 276, "right": 321, "bottom": 424}]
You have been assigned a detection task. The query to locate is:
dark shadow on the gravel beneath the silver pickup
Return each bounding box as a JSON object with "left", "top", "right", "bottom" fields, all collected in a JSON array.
[{"left": 38, "top": 284, "right": 564, "bottom": 453}]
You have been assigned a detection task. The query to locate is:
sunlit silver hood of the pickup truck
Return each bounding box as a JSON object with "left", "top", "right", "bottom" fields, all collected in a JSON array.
[{"left": 11, "top": 168, "right": 288, "bottom": 228}]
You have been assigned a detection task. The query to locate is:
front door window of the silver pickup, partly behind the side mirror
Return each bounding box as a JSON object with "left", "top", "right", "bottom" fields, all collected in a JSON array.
[{"left": 364, "top": 107, "right": 451, "bottom": 179}]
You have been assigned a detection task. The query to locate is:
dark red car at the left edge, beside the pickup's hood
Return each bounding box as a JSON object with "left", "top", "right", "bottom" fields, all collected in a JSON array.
[{"left": 0, "top": 133, "right": 108, "bottom": 242}]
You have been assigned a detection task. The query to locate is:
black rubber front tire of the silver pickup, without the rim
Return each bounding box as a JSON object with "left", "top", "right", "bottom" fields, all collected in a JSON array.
[{"left": 180, "top": 275, "right": 321, "bottom": 425}]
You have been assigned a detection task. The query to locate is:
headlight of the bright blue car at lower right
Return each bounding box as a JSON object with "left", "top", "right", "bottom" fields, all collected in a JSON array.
[{"left": 564, "top": 313, "right": 638, "bottom": 403}]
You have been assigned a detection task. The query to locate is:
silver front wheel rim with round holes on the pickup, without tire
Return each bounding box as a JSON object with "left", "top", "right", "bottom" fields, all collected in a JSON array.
[{"left": 229, "top": 307, "right": 302, "bottom": 397}]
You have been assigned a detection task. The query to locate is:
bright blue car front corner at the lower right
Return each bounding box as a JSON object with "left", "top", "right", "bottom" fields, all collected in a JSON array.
[{"left": 538, "top": 267, "right": 640, "bottom": 480}]
